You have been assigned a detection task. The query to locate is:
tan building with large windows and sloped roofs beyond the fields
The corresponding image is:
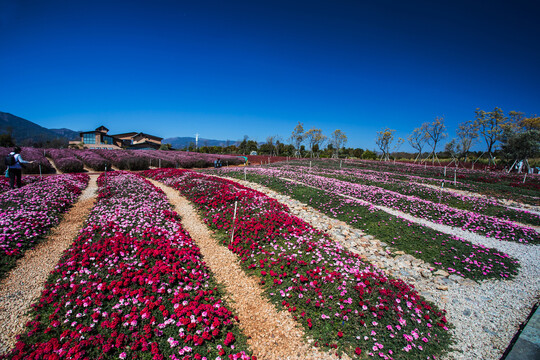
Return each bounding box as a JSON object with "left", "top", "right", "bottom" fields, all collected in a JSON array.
[{"left": 69, "top": 126, "right": 163, "bottom": 150}]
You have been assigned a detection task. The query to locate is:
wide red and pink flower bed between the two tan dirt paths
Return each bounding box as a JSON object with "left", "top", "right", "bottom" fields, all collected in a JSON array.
[{"left": 6, "top": 172, "right": 251, "bottom": 360}]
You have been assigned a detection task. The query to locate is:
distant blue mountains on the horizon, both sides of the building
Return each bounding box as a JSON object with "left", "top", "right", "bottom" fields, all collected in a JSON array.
[{"left": 0, "top": 111, "right": 236, "bottom": 149}]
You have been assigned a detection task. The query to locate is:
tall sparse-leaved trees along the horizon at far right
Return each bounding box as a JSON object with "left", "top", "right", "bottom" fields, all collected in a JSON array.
[{"left": 375, "top": 107, "right": 540, "bottom": 169}]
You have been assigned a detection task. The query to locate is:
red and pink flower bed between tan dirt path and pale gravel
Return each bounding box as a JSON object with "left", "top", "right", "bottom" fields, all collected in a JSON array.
[{"left": 144, "top": 169, "right": 451, "bottom": 359}]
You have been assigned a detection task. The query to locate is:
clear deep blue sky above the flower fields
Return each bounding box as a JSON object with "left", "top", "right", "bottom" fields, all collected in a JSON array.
[{"left": 0, "top": 0, "right": 540, "bottom": 150}]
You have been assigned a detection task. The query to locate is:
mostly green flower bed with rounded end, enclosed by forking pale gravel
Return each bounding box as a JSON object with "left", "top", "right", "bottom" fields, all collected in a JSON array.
[{"left": 217, "top": 171, "right": 519, "bottom": 280}]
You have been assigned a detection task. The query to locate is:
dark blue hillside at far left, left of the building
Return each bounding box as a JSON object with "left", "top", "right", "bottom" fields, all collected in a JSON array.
[{"left": 0, "top": 112, "right": 75, "bottom": 146}]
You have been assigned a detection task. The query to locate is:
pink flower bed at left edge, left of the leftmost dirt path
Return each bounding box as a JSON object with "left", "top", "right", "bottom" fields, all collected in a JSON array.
[{"left": 0, "top": 174, "right": 89, "bottom": 278}]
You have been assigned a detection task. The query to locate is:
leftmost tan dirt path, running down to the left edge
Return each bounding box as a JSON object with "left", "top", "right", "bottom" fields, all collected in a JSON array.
[{"left": 0, "top": 175, "right": 97, "bottom": 354}]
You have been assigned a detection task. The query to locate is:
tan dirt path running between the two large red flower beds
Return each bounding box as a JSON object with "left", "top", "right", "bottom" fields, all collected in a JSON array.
[{"left": 151, "top": 180, "right": 347, "bottom": 360}]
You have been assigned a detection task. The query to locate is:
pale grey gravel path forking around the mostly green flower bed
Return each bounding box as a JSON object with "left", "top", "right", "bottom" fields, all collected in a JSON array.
[{"left": 229, "top": 179, "right": 540, "bottom": 360}]
